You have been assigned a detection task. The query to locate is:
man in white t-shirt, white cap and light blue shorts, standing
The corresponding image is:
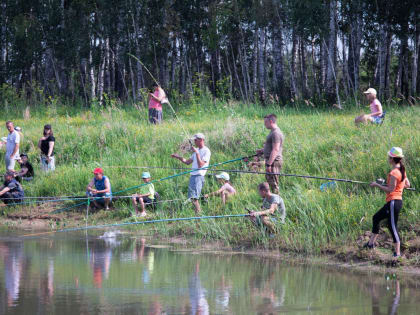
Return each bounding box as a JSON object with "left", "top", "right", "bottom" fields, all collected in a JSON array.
[{"left": 171, "top": 133, "right": 211, "bottom": 214}]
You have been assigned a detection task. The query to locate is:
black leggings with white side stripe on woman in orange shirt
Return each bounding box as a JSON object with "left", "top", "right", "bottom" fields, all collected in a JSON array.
[{"left": 372, "top": 200, "right": 402, "bottom": 243}]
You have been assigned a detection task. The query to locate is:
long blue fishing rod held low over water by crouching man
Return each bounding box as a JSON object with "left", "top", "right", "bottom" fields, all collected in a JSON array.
[{"left": 22, "top": 214, "right": 250, "bottom": 237}]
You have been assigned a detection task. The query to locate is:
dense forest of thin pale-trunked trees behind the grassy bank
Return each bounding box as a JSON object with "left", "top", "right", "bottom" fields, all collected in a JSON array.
[{"left": 0, "top": 0, "right": 420, "bottom": 107}]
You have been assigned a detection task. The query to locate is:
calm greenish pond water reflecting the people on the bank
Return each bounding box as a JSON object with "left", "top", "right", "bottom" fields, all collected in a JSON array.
[{"left": 0, "top": 231, "right": 420, "bottom": 315}]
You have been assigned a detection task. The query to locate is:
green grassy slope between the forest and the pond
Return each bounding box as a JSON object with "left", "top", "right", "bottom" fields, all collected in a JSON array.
[{"left": 0, "top": 102, "right": 420, "bottom": 260}]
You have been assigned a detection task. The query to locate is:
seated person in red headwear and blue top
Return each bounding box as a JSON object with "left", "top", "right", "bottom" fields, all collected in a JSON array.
[{"left": 86, "top": 167, "right": 112, "bottom": 210}]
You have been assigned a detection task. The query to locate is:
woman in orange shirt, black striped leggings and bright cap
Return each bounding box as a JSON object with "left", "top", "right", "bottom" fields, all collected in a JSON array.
[{"left": 364, "top": 147, "right": 410, "bottom": 257}]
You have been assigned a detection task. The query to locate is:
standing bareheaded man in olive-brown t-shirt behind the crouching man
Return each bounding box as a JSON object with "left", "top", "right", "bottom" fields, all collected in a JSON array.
[{"left": 257, "top": 114, "right": 284, "bottom": 194}]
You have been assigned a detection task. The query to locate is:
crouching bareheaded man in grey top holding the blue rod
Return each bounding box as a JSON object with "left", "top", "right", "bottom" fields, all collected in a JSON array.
[{"left": 249, "top": 182, "right": 286, "bottom": 233}]
